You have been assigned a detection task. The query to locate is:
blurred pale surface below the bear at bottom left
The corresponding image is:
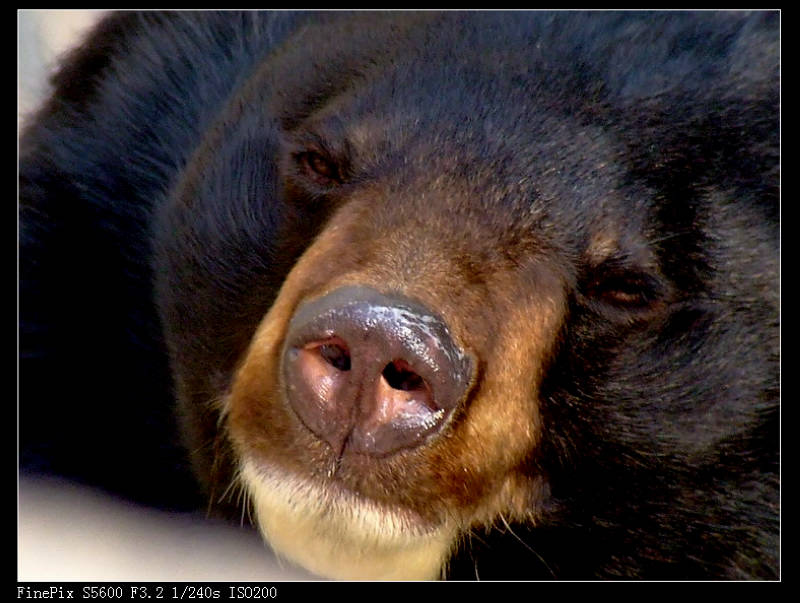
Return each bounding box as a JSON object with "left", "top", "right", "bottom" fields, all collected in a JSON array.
[{"left": 17, "top": 479, "right": 312, "bottom": 582}]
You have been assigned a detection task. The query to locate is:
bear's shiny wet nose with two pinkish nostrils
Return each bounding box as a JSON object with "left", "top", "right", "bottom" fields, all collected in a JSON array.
[{"left": 282, "top": 286, "right": 475, "bottom": 456}]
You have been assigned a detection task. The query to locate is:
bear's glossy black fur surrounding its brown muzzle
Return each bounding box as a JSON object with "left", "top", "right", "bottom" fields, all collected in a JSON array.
[{"left": 20, "top": 12, "right": 779, "bottom": 579}]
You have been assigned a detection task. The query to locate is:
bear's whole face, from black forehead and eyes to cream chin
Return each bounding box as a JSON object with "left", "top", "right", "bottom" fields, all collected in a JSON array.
[{"left": 150, "top": 13, "right": 769, "bottom": 578}]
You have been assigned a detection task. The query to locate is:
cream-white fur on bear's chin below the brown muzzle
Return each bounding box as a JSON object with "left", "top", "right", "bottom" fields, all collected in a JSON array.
[{"left": 241, "top": 461, "right": 455, "bottom": 580}]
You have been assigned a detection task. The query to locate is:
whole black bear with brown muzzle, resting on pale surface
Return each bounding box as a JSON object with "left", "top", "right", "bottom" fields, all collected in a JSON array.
[{"left": 19, "top": 11, "right": 780, "bottom": 580}]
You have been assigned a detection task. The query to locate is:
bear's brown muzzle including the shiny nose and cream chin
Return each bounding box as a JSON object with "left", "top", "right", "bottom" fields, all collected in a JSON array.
[{"left": 226, "top": 109, "right": 568, "bottom": 577}]
